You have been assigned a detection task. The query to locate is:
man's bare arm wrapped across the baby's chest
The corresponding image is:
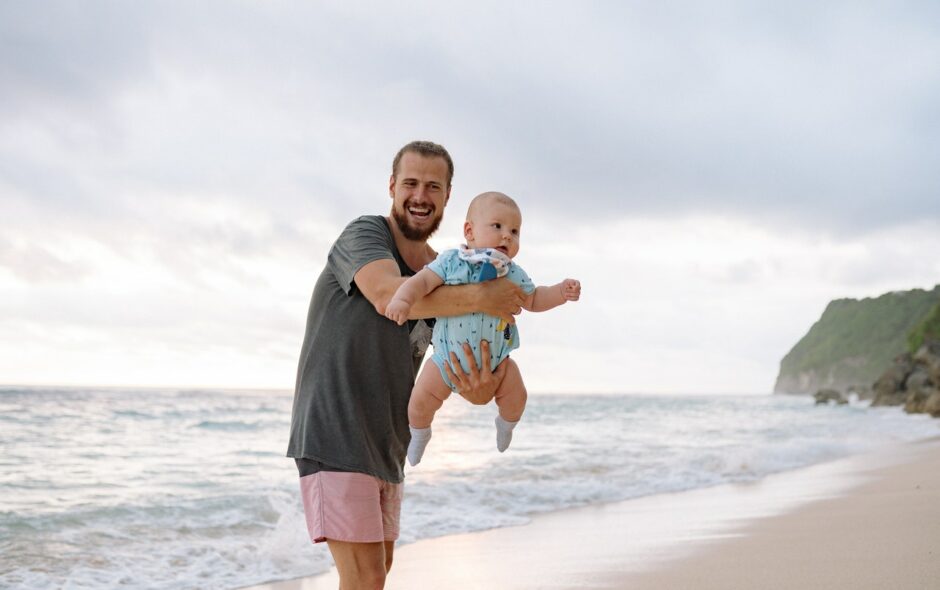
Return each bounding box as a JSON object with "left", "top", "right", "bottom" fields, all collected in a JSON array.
[{"left": 354, "top": 259, "right": 525, "bottom": 323}]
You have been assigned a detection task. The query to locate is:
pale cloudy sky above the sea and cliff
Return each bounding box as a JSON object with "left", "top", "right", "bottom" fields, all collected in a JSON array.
[{"left": 0, "top": 1, "right": 940, "bottom": 394}]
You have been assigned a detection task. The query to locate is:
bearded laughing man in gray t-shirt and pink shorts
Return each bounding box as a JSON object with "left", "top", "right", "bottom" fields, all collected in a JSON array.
[{"left": 287, "top": 141, "right": 523, "bottom": 590}]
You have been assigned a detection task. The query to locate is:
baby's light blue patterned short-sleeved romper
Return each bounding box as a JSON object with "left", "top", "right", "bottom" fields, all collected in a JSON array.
[{"left": 428, "top": 246, "right": 535, "bottom": 391}]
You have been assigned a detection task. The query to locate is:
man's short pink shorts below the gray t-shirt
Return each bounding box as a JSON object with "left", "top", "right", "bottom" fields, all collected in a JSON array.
[{"left": 300, "top": 471, "right": 405, "bottom": 543}]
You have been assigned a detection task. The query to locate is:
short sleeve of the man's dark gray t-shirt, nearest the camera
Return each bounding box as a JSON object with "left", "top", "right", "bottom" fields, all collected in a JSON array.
[{"left": 327, "top": 216, "right": 395, "bottom": 295}]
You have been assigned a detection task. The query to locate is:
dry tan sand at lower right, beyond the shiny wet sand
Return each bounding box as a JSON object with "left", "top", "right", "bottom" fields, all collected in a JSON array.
[{"left": 610, "top": 437, "right": 940, "bottom": 590}]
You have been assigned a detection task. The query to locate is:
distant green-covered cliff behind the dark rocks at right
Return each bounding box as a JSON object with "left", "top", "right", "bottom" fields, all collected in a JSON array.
[{"left": 774, "top": 285, "right": 940, "bottom": 395}]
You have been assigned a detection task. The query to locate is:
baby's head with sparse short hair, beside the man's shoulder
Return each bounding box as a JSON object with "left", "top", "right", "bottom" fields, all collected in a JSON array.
[{"left": 463, "top": 192, "right": 522, "bottom": 258}]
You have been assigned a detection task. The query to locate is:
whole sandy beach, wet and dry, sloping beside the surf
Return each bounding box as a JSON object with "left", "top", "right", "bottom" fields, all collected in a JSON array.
[{"left": 244, "top": 438, "right": 940, "bottom": 590}]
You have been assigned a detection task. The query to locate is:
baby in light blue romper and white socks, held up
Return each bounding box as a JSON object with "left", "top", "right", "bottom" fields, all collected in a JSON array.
[{"left": 385, "top": 192, "right": 581, "bottom": 465}]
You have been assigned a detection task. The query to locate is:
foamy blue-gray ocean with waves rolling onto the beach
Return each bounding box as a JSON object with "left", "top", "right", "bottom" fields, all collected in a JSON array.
[{"left": 0, "top": 388, "right": 940, "bottom": 590}]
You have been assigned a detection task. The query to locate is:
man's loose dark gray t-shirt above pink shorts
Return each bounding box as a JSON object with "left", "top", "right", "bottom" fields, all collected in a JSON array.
[{"left": 287, "top": 215, "right": 431, "bottom": 483}]
